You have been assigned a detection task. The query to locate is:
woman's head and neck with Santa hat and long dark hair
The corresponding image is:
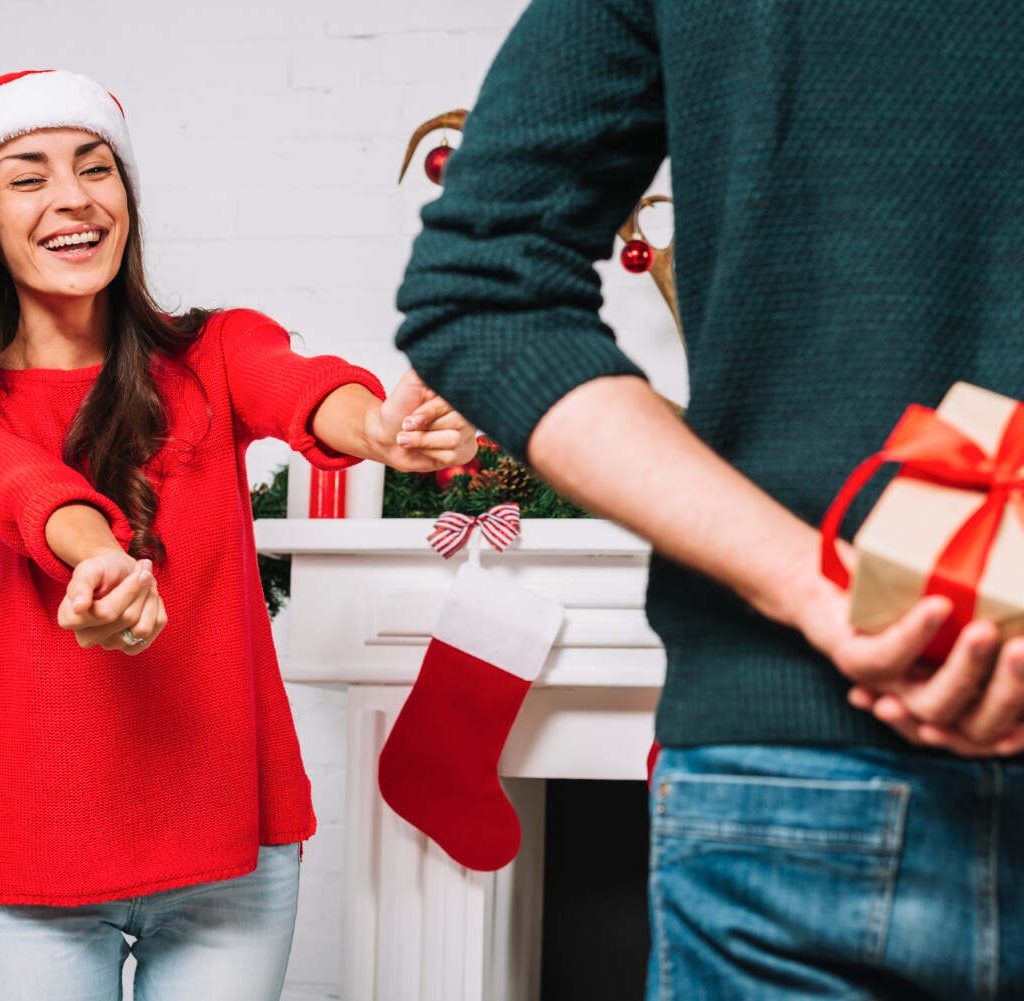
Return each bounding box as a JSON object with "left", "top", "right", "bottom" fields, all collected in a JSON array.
[{"left": 0, "top": 72, "right": 216, "bottom": 559}]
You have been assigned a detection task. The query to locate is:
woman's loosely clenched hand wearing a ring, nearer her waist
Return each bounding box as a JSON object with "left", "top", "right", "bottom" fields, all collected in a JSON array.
[{"left": 57, "top": 549, "right": 167, "bottom": 656}]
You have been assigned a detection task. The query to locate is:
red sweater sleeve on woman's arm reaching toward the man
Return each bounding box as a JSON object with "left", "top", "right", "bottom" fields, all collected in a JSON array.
[{"left": 219, "top": 309, "right": 385, "bottom": 469}]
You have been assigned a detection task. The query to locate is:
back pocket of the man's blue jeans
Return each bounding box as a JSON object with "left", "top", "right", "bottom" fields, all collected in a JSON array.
[{"left": 650, "top": 769, "right": 909, "bottom": 999}]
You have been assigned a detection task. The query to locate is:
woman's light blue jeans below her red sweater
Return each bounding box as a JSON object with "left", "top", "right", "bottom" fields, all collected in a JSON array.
[{"left": 0, "top": 844, "right": 299, "bottom": 1001}]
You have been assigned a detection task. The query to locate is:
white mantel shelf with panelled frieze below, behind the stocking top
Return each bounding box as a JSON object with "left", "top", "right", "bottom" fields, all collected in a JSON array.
[{"left": 256, "top": 518, "right": 665, "bottom": 688}]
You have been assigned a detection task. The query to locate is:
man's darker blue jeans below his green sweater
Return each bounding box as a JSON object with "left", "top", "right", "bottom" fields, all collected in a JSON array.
[{"left": 647, "top": 745, "right": 1024, "bottom": 1001}]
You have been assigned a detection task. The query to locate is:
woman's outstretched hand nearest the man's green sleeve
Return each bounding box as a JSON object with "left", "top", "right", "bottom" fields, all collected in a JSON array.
[{"left": 367, "top": 368, "right": 476, "bottom": 473}]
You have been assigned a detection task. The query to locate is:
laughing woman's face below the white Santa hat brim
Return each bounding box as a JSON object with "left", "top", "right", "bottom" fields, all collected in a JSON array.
[{"left": 0, "top": 129, "right": 129, "bottom": 298}]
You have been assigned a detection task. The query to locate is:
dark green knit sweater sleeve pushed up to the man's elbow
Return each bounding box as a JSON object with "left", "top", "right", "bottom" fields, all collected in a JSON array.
[{"left": 396, "top": 0, "right": 666, "bottom": 458}]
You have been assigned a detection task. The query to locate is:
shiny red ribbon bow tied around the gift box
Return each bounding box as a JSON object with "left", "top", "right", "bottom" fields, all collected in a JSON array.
[{"left": 821, "top": 403, "right": 1024, "bottom": 661}]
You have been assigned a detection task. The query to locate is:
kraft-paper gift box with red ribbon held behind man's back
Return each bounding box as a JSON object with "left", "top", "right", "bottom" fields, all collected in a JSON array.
[{"left": 821, "top": 383, "right": 1024, "bottom": 660}]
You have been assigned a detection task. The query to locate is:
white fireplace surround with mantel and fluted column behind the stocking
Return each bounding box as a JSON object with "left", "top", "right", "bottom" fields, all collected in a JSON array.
[{"left": 256, "top": 518, "right": 665, "bottom": 1001}]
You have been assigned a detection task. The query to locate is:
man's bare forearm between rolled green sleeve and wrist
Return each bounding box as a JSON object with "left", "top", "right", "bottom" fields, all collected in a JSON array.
[{"left": 527, "top": 376, "right": 818, "bottom": 625}]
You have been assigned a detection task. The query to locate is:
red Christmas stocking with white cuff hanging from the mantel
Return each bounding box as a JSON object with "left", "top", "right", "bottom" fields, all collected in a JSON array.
[{"left": 378, "top": 564, "right": 562, "bottom": 872}]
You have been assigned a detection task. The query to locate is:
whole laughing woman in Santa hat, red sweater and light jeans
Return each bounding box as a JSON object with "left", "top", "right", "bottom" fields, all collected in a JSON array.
[{"left": 0, "top": 71, "right": 476, "bottom": 1001}]
